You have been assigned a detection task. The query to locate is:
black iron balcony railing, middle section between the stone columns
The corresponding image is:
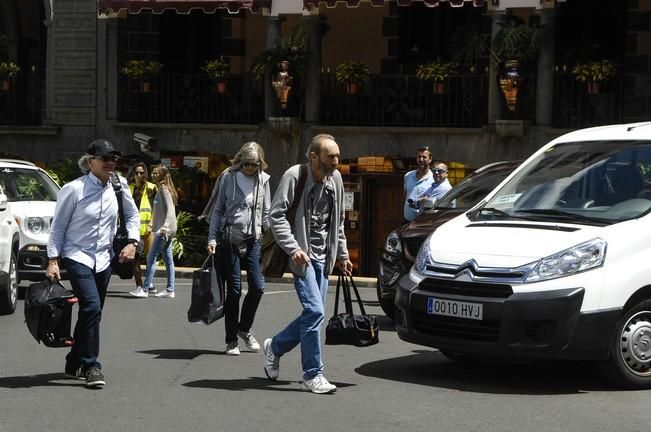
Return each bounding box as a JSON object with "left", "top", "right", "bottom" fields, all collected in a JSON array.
[{"left": 321, "top": 74, "right": 488, "bottom": 127}]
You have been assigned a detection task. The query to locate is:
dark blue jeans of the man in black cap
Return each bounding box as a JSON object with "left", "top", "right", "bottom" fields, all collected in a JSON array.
[{"left": 62, "top": 258, "right": 111, "bottom": 370}]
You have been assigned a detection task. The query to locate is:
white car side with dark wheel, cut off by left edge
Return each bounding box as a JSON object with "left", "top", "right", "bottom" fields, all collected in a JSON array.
[{"left": 0, "top": 187, "right": 20, "bottom": 315}]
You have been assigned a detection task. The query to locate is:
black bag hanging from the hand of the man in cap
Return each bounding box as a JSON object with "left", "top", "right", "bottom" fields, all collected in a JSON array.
[{"left": 25, "top": 279, "right": 78, "bottom": 348}]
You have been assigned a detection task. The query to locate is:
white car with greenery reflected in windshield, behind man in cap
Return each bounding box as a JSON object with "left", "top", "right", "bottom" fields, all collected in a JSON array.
[{"left": 0, "top": 159, "right": 60, "bottom": 282}]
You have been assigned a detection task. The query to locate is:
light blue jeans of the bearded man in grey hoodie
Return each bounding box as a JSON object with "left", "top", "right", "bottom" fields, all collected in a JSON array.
[{"left": 271, "top": 260, "right": 328, "bottom": 380}]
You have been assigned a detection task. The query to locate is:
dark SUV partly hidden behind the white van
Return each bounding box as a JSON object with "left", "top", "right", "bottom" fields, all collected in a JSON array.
[{"left": 377, "top": 161, "right": 521, "bottom": 318}]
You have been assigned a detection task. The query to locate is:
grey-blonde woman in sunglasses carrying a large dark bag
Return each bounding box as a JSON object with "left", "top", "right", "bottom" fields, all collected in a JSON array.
[{"left": 208, "top": 142, "right": 271, "bottom": 355}]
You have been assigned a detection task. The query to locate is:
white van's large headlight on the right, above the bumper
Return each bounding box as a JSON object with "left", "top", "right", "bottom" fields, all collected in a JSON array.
[{"left": 524, "top": 238, "right": 606, "bottom": 283}]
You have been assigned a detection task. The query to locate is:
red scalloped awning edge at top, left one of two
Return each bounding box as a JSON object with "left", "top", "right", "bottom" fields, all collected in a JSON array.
[{"left": 97, "top": 0, "right": 271, "bottom": 14}]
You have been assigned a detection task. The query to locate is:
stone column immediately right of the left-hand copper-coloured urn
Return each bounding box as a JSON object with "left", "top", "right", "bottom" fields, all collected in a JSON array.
[{"left": 303, "top": 13, "right": 321, "bottom": 123}]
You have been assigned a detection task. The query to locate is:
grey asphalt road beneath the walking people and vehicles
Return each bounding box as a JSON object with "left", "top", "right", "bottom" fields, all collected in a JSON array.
[{"left": 0, "top": 279, "right": 651, "bottom": 432}]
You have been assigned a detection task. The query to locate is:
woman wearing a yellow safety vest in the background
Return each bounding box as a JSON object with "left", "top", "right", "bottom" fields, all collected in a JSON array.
[{"left": 129, "top": 162, "right": 156, "bottom": 297}]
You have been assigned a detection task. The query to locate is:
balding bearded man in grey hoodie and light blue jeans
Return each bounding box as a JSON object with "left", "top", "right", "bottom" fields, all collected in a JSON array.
[{"left": 263, "top": 134, "right": 353, "bottom": 394}]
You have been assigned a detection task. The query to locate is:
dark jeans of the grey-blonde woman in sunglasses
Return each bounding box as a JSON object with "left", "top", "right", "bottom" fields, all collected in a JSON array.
[{"left": 220, "top": 241, "right": 264, "bottom": 344}]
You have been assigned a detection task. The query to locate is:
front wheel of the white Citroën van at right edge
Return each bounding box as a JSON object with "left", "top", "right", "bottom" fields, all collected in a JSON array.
[{"left": 605, "top": 300, "right": 651, "bottom": 389}]
